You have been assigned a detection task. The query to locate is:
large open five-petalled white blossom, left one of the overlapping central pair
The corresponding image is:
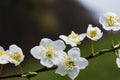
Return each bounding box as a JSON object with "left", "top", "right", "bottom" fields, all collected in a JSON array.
[{"left": 30, "top": 38, "right": 66, "bottom": 68}]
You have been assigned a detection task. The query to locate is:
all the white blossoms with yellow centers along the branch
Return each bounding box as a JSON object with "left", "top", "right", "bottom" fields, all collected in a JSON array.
[{"left": 0, "top": 12, "right": 120, "bottom": 80}]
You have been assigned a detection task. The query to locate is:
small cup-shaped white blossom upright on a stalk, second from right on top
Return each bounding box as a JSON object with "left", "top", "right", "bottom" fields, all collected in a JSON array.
[{"left": 87, "top": 24, "right": 103, "bottom": 41}]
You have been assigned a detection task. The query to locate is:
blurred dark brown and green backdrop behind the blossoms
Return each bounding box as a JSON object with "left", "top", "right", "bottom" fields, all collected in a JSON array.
[{"left": 0, "top": 0, "right": 120, "bottom": 80}]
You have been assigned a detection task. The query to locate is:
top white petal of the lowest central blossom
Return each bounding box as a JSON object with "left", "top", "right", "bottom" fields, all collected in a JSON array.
[{"left": 68, "top": 47, "right": 80, "bottom": 59}]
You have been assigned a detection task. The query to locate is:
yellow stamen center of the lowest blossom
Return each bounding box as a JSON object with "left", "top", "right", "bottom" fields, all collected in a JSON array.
[{"left": 63, "top": 58, "right": 75, "bottom": 71}]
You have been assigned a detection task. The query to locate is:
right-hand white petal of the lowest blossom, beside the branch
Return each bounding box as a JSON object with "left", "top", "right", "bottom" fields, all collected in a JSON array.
[{"left": 75, "top": 58, "right": 88, "bottom": 69}]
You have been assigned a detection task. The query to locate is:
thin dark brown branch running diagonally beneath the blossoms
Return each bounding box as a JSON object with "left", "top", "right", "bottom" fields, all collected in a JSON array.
[{"left": 0, "top": 45, "right": 120, "bottom": 79}]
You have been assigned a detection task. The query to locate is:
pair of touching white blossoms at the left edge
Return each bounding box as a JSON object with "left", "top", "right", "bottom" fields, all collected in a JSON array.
[{"left": 0, "top": 44, "right": 24, "bottom": 66}]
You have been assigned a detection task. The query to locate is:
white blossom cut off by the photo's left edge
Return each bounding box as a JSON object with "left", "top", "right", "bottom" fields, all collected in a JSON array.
[{"left": 0, "top": 46, "right": 9, "bottom": 64}]
